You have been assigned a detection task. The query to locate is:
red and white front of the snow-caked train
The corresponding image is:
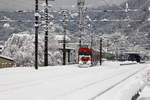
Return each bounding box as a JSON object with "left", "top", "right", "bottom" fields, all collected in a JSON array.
[{"left": 78, "top": 47, "right": 92, "bottom": 67}]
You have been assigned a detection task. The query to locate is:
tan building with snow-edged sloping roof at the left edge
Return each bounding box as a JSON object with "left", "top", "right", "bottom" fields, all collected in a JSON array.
[{"left": 0, "top": 55, "right": 14, "bottom": 68}]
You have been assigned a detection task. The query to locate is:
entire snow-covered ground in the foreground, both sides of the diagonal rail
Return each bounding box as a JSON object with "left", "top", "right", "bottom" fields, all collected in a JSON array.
[{"left": 0, "top": 62, "right": 150, "bottom": 100}]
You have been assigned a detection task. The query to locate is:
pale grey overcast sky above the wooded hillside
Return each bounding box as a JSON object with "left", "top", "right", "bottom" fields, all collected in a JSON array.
[{"left": 0, "top": 0, "right": 125, "bottom": 10}]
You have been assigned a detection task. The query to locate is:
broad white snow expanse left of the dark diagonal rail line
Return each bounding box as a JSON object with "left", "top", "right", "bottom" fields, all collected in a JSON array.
[{"left": 0, "top": 62, "right": 148, "bottom": 100}]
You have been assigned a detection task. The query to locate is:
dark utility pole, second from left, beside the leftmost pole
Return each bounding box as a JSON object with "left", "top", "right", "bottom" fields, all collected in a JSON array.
[{"left": 44, "top": 0, "right": 48, "bottom": 66}]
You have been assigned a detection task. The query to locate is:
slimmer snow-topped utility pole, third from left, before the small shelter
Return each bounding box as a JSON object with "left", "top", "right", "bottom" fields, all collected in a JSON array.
[{"left": 62, "top": 11, "right": 67, "bottom": 65}]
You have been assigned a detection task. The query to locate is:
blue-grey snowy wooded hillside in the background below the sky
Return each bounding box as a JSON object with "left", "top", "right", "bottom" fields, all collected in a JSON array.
[{"left": 0, "top": 0, "right": 150, "bottom": 49}]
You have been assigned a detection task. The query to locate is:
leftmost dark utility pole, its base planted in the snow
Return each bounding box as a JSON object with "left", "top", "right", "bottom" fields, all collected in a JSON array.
[{"left": 35, "top": 0, "right": 39, "bottom": 70}]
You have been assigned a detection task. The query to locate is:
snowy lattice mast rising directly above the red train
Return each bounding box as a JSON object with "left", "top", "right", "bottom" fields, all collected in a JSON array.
[{"left": 77, "top": 0, "right": 85, "bottom": 47}]
